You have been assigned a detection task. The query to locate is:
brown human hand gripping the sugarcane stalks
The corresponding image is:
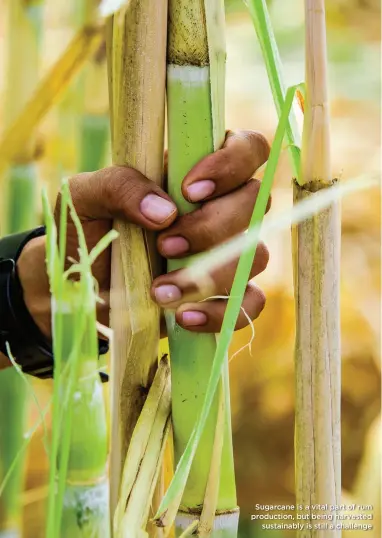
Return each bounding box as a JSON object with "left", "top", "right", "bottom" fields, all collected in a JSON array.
[{"left": 18, "top": 131, "right": 269, "bottom": 336}]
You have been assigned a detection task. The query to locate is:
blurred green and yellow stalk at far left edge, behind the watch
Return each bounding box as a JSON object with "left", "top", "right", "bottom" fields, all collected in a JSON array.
[{"left": 0, "top": 0, "right": 42, "bottom": 538}]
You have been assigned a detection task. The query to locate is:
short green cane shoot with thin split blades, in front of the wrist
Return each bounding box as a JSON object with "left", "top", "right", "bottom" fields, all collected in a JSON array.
[{"left": 44, "top": 184, "right": 110, "bottom": 538}]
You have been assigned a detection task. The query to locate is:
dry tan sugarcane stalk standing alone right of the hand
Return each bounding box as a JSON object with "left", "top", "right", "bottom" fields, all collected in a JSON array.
[{"left": 294, "top": 0, "right": 341, "bottom": 538}]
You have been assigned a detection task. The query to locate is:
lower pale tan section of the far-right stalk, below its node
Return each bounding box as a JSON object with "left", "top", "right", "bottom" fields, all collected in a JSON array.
[{"left": 294, "top": 184, "right": 341, "bottom": 538}]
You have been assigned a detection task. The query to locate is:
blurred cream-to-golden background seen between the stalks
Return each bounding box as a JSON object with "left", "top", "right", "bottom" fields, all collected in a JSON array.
[{"left": 0, "top": 0, "right": 381, "bottom": 538}]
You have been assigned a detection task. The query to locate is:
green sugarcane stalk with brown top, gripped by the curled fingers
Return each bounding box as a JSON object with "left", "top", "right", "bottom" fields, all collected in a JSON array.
[{"left": 166, "top": 0, "right": 238, "bottom": 537}]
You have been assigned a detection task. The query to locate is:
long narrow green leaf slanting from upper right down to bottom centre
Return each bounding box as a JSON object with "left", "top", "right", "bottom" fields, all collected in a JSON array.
[{"left": 155, "top": 85, "right": 299, "bottom": 526}]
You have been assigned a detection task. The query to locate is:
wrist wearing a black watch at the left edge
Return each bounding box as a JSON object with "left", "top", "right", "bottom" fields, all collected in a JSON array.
[{"left": 0, "top": 227, "right": 52, "bottom": 377}]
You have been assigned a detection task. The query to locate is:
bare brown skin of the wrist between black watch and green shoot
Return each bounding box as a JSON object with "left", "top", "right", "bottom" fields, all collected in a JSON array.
[{"left": 16, "top": 236, "right": 51, "bottom": 338}]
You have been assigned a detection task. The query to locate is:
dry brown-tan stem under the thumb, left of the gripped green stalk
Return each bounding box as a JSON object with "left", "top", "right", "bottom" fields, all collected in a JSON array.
[{"left": 107, "top": 0, "right": 167, "bottom": 513}]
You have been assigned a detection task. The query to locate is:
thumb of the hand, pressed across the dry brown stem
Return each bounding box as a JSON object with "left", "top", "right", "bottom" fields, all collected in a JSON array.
[{"left": 55, "top": 166, "right": 177, "bottom": 230}]
